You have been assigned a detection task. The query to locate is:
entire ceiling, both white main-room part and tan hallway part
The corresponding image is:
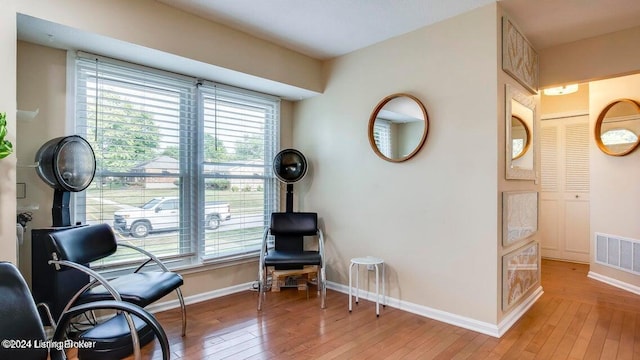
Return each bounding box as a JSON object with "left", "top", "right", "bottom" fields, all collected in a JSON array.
[{"left": 157, "top": 0, "right": 640, "bottom": 59}]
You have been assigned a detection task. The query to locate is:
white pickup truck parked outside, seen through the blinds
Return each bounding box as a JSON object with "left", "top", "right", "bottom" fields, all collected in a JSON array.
[{"left": 113, "top": 197, "right": 231, "bottom": 238}]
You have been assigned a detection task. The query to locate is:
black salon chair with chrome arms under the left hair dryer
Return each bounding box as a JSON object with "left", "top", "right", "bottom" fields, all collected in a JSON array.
[{"left": 48, "top": 224, "right": 187, "bottom": 336}]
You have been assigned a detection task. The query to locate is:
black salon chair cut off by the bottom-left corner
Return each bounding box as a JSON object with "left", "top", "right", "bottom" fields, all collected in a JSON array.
[{"left": 0, "top": 262, "right": 170, "bottom": 360}]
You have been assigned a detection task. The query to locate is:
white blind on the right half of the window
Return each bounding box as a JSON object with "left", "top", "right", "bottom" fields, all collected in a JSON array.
[{"left": 199, "top": 83, "right": 279, "bottom": 259}]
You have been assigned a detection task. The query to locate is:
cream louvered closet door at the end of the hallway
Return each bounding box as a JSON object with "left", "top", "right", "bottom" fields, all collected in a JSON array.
[{"left": 539, "top": 115, "right": 590, "bottom": 262}]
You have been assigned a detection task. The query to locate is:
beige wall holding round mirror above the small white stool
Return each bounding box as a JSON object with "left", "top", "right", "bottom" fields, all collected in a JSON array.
[{"left": 293, "top": 4, "right": 498, "bottom": 324}]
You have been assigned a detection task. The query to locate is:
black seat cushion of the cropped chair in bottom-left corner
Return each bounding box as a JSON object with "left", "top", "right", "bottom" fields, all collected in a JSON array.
[{"left": 78, "top": 313, "right": 155, "bottom": 360}]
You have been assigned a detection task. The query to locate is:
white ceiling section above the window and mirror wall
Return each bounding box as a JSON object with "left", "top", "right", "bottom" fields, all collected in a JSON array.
[{"left": 157, "top": 0, "right": 495, "bottom": 59}]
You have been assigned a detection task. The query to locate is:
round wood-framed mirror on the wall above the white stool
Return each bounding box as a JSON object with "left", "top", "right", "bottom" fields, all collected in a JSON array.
[{"left": 369, "top": 94, "right": 429, "bottom": 162}]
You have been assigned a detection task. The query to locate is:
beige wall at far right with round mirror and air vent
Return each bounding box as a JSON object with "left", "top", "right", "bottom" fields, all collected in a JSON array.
[{"left": 589, "top": 75, "right": 640, "bottom": 287}]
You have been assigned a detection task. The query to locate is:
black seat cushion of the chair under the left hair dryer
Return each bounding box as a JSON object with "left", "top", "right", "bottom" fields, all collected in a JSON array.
[{"left": 78, "top": 271, "right": 184, "bottom": 307}]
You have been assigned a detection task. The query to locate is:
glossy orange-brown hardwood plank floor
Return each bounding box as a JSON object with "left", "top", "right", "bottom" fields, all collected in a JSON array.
[{"left": 119, "top": 260, "right": 640, "bottom": 359}]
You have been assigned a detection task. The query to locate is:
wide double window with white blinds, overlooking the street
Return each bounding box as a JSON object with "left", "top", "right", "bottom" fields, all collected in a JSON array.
[{"left": 74, "top": 53, "right": 280, "bottom": 266}]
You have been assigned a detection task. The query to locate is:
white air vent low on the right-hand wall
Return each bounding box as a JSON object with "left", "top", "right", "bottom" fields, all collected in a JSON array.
[{"left": 596, "top": 233, "right": 640, "bottom": 275}]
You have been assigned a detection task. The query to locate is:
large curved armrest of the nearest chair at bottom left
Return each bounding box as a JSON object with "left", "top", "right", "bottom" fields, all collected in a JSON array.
[{"left": 50, "top": 300, "right": 170, "bottom": 360}]
